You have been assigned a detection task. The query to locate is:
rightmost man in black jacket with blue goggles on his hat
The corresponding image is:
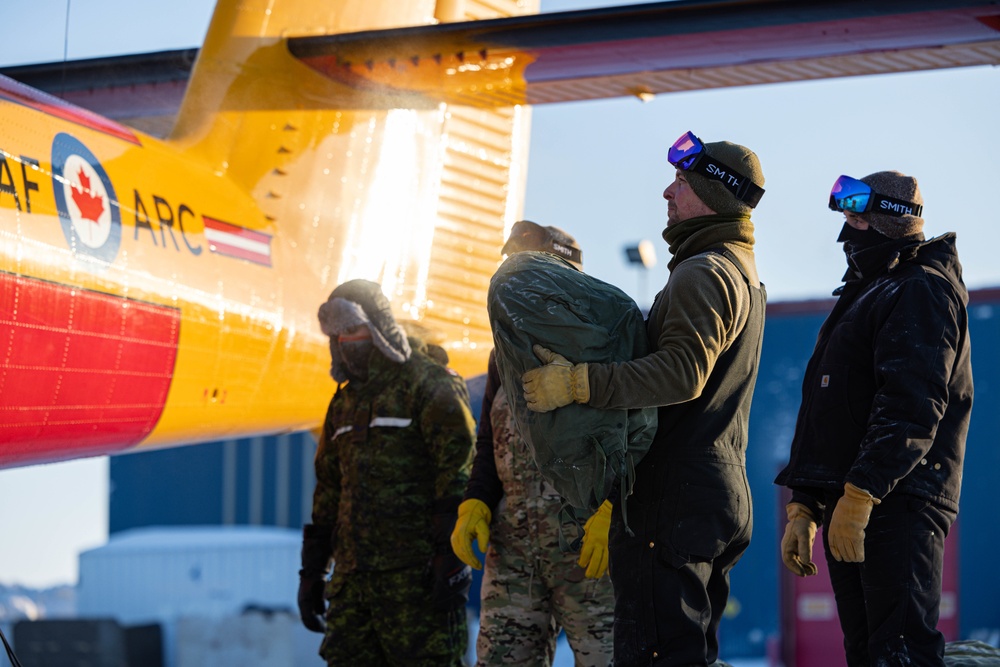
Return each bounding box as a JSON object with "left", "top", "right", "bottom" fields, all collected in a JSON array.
[{"left": 775, "top": 171, "right": 973, "bottom": 667}]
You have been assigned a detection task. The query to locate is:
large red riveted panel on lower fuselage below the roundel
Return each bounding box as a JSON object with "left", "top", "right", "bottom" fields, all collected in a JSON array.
[{"left": 0, "top": 272, "right": 180, "bottom": 467}]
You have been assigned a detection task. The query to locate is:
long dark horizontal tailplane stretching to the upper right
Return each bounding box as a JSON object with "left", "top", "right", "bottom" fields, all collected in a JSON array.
[{"left": 288, "top": 0, "right": 1000, "bottom": 107}]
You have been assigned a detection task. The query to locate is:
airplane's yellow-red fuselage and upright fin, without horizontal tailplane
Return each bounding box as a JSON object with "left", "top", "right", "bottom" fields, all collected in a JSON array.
[{"left": 0, "top": 0, "right": 530, "bottom": 467}]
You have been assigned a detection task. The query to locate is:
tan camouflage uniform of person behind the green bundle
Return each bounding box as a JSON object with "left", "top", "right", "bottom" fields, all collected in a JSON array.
[{"left": 466, "top": 357, "right": 614, "bottom": 667}]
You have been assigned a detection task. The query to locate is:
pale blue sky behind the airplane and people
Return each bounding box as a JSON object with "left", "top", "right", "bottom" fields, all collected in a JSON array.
[{"left": 0, "top": 0, "right": 1000, "bottom": 586}]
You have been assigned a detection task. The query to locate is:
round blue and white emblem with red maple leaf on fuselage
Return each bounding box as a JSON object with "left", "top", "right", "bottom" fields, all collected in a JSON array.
[{"left": 52, "top": 133, "right": 122, "bottom": 264}]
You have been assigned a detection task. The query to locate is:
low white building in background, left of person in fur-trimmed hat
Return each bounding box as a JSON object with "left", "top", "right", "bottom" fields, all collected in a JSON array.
[{"left": 77, "top": 526, "right": 312, "bottom": 667}]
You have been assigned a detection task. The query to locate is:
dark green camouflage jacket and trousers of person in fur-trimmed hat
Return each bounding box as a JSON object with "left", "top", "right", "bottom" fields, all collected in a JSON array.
[{"left": 313, "top": 351, "right": 474, "bottom": 667}]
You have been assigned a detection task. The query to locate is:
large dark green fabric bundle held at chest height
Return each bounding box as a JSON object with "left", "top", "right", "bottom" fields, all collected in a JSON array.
[{"left": 488, "top": 252, "right": 656, "bottom": 513}]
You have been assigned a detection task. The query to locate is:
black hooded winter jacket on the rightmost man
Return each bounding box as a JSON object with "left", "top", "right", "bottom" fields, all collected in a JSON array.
[{"left": 775, "top": 234, "right": 972, "bottom": 511}]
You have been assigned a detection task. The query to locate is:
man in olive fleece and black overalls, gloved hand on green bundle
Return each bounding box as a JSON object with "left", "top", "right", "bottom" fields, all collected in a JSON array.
[{"left": 522, "top": 132, "right": 766, "bottom": 667}]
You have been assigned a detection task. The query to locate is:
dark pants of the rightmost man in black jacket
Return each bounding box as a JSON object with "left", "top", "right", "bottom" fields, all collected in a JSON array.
[{"left": 823, "top": 493, "right": 956, "bottom": 667}]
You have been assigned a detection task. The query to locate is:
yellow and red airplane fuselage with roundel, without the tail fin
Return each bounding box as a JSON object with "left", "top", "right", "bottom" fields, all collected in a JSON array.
[{"left": 0, "top": 74, "right": 333, "bottom": 465}]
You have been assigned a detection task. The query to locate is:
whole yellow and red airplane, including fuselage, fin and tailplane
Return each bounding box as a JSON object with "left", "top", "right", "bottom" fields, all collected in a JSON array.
[{"left": 0, "top": 0, "right": 1000, "bottom": 467}]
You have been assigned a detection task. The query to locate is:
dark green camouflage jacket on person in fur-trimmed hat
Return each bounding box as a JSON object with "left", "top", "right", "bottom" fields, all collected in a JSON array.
[{"left": 312, "top": 351, "right": 475, "bottom": 572}]
